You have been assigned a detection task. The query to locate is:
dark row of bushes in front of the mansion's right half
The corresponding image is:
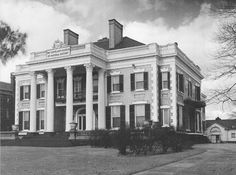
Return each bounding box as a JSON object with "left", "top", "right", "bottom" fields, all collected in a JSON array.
[{"left": 90, "top": 127, "right": 207, "bottom": 155}]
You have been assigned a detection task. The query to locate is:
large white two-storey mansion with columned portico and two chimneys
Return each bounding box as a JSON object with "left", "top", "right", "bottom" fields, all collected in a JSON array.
[{"left": 14, "top": 19, "right": 204, "bottom": 133}]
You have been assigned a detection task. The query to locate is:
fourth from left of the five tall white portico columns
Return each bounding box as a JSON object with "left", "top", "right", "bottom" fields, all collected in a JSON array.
[{"left": 84, "top": 63, "right": 93, "bottom": 130}]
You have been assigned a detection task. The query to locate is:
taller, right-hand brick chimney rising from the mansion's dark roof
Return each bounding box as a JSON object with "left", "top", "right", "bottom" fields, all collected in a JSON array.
[{"left": 109, "top": 19, "right": 123, "bottom": 49}]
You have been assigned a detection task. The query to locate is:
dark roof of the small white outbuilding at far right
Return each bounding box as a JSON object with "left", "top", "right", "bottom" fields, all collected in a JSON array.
[{"left": 206, "top": 119, "right": 236, "bottom": 129}]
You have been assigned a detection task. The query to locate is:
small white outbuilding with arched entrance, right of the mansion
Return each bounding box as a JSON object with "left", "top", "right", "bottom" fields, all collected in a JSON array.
[{"left": 205, "top": 118, "right": 236, "bottom": 143}]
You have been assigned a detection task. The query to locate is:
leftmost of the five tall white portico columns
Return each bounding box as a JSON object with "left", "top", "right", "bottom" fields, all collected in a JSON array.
[{"left": 30, "top": 72, "right": 37, "bottom": 132}]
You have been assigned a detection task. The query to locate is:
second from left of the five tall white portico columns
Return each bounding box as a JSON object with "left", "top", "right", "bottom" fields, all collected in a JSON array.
[{"left": 47, "top": 69, "right": 54, "bottom": 132}]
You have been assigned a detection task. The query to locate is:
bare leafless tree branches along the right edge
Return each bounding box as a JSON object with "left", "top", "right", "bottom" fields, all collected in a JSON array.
[{"left": 208, "top": 0, "right": 236, "bottom": 104}]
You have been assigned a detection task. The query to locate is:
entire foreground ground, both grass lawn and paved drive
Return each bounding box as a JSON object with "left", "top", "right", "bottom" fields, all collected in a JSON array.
[{"left": 0, "top": 144, "right": 236, "bottom": 175}]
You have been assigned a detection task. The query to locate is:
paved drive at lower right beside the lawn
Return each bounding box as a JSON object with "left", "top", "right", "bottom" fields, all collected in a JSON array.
[{"left": 135, "top": 144, "right": 236, "bottom": 175}]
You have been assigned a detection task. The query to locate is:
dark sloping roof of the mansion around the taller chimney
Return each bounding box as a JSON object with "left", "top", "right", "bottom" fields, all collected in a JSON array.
[{"left": 93, "top": 36, "right": 145, "bottom": 50}]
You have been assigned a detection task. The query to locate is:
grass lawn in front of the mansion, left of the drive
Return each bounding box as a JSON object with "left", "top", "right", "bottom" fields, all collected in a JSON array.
[{"left": 0, "top": 146, "right": 204, "bottom": 175}]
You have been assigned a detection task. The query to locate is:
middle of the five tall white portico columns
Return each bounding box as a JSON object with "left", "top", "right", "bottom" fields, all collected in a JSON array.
[{"left": 65, "top": 66, "right": 73, "bottom": 131}]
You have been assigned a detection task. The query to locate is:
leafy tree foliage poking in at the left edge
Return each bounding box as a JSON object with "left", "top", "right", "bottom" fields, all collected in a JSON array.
[{"left": 0, "top": 21, "right": 27, "bottom": 65}]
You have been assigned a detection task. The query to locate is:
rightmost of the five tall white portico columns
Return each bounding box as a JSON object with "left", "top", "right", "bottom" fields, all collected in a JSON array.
[{"left": 98, "top": 69, "right": 106, "bottom": 129}]
